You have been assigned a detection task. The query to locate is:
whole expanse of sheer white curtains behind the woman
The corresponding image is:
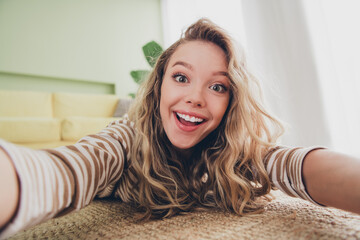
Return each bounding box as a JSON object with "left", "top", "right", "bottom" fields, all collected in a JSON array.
[{"left": 162, "top": 0, "right": 360, "bottom": 154}]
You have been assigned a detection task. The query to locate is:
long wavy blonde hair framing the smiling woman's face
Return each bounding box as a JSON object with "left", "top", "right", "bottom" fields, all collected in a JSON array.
[{"left": 119, "top": 19, "right": 283, "bottom": 219}]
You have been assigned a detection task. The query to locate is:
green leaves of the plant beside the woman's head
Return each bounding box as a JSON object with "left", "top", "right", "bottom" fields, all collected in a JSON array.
[{"left": 129, "top": 41, "right": 163, "bottom": 98}]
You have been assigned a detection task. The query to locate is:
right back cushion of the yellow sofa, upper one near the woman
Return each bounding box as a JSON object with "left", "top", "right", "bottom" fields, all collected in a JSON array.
[{"left": 54, "top": 93, "right": 119, "bottom": 118}]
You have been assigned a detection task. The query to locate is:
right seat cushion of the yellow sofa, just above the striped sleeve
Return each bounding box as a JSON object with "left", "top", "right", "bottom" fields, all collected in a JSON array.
[{"left": 61, "top": 117, "right": 119, "bottom": 141}]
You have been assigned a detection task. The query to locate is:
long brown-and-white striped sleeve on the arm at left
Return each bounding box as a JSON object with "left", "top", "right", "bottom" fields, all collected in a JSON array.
[{"left": 0, "top": 119, "right": 134, "bottom": 239}]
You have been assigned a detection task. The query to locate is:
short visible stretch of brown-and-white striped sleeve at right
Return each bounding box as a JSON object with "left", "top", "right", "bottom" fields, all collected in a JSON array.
[{"left": 264, "top": 147, "right": 323, "bottom": 206}]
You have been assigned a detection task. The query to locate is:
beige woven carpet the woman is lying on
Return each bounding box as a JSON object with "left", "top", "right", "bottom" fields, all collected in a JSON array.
[{"left": 7, "top": 191, "right": 360, "bottom": 240}]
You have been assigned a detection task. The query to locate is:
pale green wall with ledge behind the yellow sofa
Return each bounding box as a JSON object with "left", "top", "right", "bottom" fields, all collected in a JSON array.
[{"left": 0, "top": 0, "right": 163, "bottom": 96}]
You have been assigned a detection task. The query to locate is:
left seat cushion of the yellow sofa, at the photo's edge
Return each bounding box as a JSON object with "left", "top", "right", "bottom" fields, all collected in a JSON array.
[{"left": 0, "top": 117, "right": 61, "bottom": 143}]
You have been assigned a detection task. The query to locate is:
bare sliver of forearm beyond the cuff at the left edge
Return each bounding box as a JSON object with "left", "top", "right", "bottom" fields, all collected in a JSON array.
[{"left": 0, "top": 148, "right": 19, "bottom": 229}]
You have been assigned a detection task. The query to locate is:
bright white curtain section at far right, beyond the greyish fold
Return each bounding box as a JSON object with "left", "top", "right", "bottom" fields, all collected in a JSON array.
[{"left": 303, "top": 0, "right": 360, "bottom": 156}]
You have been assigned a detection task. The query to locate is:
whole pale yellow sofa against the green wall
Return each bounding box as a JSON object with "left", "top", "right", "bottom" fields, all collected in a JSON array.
[{"left": 0, "top": 90, "right": 130, "bottom": 149}]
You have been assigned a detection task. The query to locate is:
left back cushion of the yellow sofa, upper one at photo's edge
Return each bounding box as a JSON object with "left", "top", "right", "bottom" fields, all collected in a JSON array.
[{"left": 0, "top": 90, "right": 53, "bottom": 117}]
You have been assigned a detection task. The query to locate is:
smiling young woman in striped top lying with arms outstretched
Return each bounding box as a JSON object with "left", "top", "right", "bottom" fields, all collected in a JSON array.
[{"left": 0, "top": 19, "right": 360, "bottom": 237}]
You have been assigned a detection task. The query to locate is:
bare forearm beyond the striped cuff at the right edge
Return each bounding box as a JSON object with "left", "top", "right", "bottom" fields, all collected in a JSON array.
[{"left": 302, "top": 149, "right": 360, "bottom": 214}]
